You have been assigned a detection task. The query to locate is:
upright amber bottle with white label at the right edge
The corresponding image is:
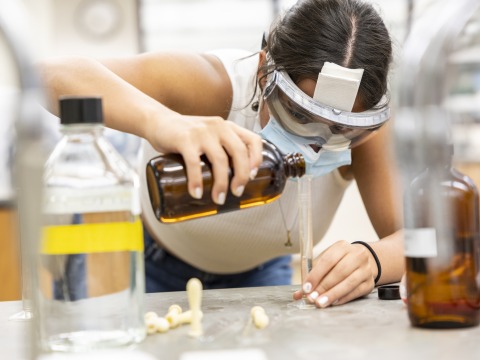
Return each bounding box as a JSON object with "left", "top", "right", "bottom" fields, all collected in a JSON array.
[{"left": 405, "top": 146, "right": 480, "bottom": 328}]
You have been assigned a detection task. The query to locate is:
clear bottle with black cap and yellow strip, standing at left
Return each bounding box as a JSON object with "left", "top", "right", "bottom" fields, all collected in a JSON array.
[{"left": 35, "top": 97, "right": 146, "bottom": 352}]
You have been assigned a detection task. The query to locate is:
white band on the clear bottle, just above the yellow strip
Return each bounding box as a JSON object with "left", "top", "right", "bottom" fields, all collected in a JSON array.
[{"left": 43, "top": 186, "right": 140, "bottom": 215}]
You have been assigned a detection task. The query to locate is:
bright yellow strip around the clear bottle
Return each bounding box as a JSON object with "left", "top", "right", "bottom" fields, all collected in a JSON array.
[{"left": 40, "top": 220, "right": 143, "bottom": 255}]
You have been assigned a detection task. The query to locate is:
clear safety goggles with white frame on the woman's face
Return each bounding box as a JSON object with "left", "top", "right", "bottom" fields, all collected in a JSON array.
[{"left": 263, "top": 70, "right": 390, "bottom": 151}]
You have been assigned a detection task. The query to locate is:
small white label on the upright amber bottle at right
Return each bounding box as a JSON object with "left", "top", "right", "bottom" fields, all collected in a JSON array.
[{"left": 404, "top": 228, "right": 437, "bottom": 258}]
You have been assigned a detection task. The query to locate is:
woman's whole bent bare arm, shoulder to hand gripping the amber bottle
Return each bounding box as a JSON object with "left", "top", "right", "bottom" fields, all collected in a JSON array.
[{"left": 41, "top": 53, "right": 262, "bottom": 203}]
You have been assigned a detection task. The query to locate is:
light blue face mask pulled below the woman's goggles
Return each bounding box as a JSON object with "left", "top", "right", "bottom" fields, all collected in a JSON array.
[{"left": 259, "top": 117, "right": 352, "bottom": 176}]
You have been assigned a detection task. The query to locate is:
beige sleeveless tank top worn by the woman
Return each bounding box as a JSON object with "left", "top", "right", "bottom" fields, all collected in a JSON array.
[{"left": 139, "top": 49, "right": 350, "bottom": 274}]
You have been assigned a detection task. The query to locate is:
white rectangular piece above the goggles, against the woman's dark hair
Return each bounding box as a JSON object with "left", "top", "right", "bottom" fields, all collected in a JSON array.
[{"left": 313, "top": 62, "right": 363, "bottom": 112}]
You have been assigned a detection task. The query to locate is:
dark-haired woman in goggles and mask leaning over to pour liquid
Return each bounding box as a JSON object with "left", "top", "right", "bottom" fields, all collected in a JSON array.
[{"left": 42, "top": 0, "right": 404, "bottom": 307}]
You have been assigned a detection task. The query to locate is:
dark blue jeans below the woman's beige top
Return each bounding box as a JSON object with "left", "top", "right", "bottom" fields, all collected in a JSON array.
[{"left": 143, "top": 227, "right": 292, "bottom": 293}]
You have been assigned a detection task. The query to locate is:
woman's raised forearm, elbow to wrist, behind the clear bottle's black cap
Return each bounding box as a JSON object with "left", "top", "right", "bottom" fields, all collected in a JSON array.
[{"left": 40, "top": 58, "right": 175, "bottom": 138}]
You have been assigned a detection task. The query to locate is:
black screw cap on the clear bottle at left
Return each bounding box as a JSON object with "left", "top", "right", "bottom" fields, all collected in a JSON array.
[{"left": 60, "top": 96, "right": 103, "bottom": 125}]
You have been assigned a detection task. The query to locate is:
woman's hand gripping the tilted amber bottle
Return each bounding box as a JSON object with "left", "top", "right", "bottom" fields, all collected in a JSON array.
[{"left": 145, "top": 114, "right": 263, "bottom": 204}]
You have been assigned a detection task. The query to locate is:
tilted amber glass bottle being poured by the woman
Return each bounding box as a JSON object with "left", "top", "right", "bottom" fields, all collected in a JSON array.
[{"left": 146, "top": 140, "right": 305, "bottom": 223}]
